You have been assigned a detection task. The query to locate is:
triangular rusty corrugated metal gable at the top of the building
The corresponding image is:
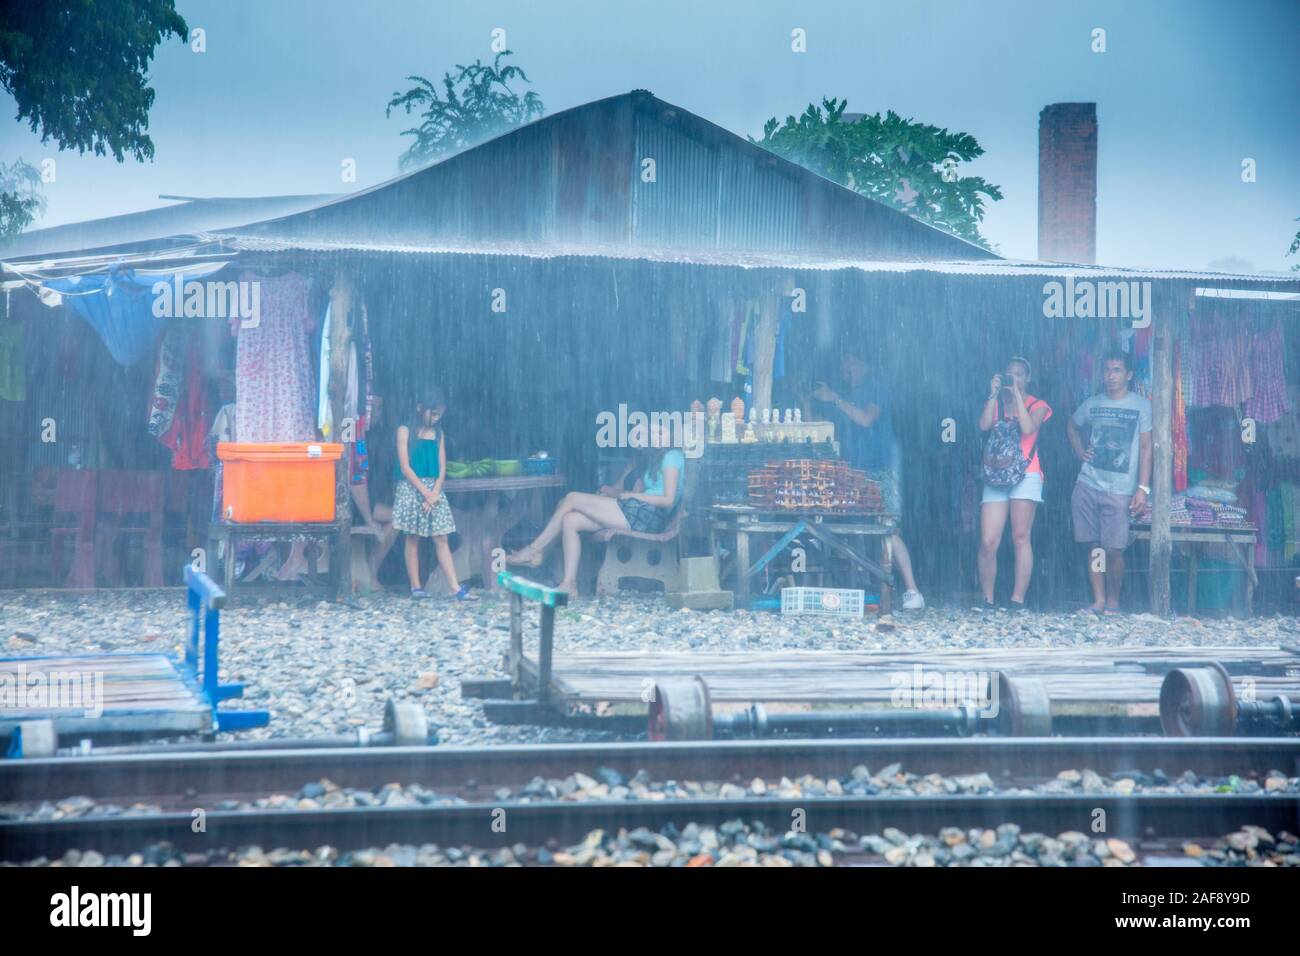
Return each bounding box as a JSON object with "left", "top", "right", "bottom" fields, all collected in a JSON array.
[{"left": 229, "top": 91, "right": 997, "bottom": 259}]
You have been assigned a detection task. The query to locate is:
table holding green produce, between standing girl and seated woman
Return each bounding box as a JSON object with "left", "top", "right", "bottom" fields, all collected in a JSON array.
[{"left": 425, "top": 475, "right": 566, "bottom": 593}]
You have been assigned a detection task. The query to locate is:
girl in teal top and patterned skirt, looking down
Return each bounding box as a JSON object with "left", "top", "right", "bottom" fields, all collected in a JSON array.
[{"left": 393, "top": 389, "right": 469, "bottom": 601}]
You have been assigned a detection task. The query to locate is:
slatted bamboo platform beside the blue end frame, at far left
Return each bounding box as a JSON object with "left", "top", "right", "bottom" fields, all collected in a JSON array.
[{"left": 0, "top": 654, "right": 213, "bottom": 736}]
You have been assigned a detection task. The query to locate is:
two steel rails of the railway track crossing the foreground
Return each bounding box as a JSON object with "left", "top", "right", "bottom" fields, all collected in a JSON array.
[{"left": 0, "top": 737, "right": 1300, "bottom": 861}]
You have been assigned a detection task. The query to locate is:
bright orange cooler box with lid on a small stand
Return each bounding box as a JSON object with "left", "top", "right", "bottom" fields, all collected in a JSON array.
[{"left": 217, "top": 441, "right": 343, "bottom": 524}]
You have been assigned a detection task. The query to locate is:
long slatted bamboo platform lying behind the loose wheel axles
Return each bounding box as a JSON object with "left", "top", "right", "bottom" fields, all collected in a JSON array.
[{"left": 521, "top": 645, "right": 1300, "bottom": 718}]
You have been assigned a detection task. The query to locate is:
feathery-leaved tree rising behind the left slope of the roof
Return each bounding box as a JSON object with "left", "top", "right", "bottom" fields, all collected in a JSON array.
[{"left": 384, "top": 49, "right": 545, "bottom": 169}]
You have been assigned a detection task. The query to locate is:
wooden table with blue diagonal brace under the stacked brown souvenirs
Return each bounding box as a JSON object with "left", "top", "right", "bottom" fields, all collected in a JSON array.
[{"left": 709, "top": 505, "right": 898, "bottom": 614}]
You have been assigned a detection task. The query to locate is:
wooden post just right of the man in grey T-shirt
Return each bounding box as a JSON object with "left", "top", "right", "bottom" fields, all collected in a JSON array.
[{"left": 1151, "top": 293, "right": 1178, "bottom": 617}]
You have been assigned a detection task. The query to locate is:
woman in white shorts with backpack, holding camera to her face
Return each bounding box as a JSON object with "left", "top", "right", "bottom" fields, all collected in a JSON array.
[{"left": 979, "top": 355, "right": 1052, "bottom": 610}]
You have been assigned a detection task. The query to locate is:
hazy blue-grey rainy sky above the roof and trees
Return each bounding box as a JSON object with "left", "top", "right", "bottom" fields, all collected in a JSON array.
[{"left": 0, "top": 0, "right": 1300, "bottom": 269}]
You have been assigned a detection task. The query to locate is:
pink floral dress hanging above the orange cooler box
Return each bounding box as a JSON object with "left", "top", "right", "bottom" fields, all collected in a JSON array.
[{"left": 231, "top": 272, "right": 316, "bottom": 442}]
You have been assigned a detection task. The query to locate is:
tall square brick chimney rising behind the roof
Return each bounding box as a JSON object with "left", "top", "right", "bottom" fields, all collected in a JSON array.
[{"left": 1039, "top": 103, "right": 1097, "bottom": 263}]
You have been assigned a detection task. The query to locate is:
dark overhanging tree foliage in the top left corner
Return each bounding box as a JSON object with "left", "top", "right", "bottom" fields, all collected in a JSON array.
[{"left": 0, "top": 0, "right": 190, "bottom": 163}]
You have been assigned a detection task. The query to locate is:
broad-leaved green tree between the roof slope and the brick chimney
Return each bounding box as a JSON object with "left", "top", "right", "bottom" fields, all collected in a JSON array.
[{"left": 750, "top": 99, "right": 1002, "bottom": 248}]
